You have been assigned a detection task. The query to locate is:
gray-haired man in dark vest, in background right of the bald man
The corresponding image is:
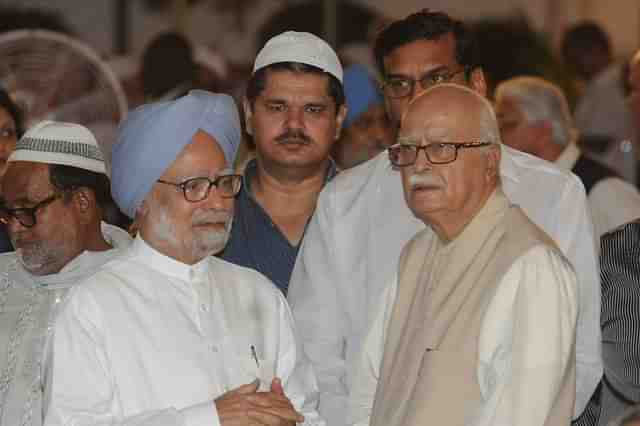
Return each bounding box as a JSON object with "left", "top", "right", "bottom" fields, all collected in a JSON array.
[{"left": 496, "top": 77, "right": 640, "bottom": 236}]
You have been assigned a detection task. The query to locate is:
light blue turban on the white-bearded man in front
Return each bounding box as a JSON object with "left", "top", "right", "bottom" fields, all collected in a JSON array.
[{"left": 111, "top": 90, "right": 240, "bottom": 218}]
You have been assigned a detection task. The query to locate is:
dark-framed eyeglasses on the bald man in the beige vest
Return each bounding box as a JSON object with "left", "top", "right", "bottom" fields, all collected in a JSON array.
[{"left": 387, "top": 141, "right": 492, "bottom": 167}]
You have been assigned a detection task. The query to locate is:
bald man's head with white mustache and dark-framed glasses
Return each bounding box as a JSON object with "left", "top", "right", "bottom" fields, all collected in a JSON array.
[{"left": 390, "top": 84, "right": 500, "bottom": 240}]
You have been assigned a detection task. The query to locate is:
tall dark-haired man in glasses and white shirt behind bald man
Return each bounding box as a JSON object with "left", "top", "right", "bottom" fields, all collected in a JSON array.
[{"left": 287, "top": 11, "right": 602, "bottom": 425}]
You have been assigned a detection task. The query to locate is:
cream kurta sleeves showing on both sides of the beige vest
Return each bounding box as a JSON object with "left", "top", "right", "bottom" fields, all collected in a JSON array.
[{"left": 347, "top": 246, "right": 578, "bottom": 426}]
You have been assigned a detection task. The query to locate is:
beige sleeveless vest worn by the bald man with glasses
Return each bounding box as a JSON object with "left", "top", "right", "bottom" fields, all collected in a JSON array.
[{"left": 371, "top": 189, "right": 575, "bottom": 426}]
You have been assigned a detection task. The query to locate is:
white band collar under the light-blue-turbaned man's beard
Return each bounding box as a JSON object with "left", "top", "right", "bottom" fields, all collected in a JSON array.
[{"left": 130, "top": 233, "right": 210, "bottom": 282}]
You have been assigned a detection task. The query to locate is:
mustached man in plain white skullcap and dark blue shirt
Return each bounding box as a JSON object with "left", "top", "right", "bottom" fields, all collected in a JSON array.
[{"left": 222, "top": 31, "right": 346, "bottom": 295}]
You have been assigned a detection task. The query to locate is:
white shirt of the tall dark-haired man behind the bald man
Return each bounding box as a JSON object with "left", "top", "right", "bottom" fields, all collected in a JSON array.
[{"left": 288, "top": 146, "right": 602, "bottom": 426}]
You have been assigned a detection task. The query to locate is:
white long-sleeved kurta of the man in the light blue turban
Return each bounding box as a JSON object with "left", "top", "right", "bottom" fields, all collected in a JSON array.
[{"left": 45, "top": 237, "right": 324, "bottom": 426}]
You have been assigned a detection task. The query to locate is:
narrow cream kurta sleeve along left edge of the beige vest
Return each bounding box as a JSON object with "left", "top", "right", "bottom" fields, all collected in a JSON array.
[{"left": 347, "top": 279, "right": 398, "bottom": 426}]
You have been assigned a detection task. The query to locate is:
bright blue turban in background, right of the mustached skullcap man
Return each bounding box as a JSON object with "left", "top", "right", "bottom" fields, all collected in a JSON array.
[{"left": 344, "top": 64, "right": 382, "bottom": 127}]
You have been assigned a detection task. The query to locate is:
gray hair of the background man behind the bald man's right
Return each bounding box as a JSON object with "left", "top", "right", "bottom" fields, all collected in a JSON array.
[{"left": 496, "top": 77, "right": 575, "bottom": 146}]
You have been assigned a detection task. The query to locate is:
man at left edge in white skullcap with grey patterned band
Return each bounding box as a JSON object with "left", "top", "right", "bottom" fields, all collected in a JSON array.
[{"left": 0, "top": 121, "right": 130, "bottom": 426}]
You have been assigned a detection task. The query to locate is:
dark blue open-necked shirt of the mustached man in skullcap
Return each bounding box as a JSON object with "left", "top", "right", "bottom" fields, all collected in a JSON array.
[{"left": 221, "top": 160, "right": 336, "bottom": 296}]
